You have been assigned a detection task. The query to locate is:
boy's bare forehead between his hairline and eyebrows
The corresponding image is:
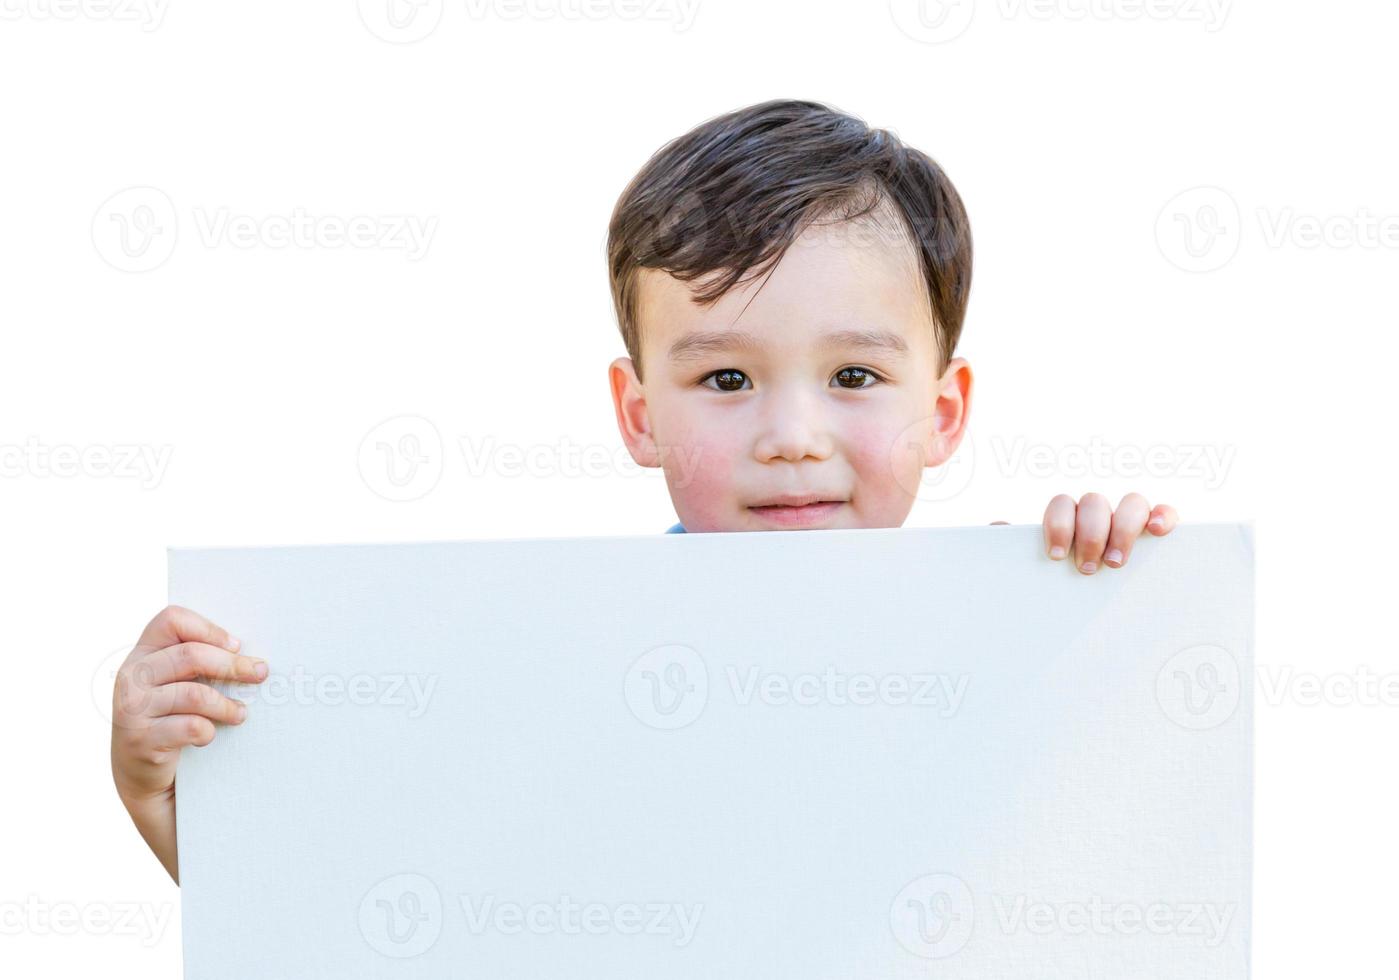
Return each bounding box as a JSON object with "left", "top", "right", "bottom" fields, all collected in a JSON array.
[{"left": 637, "top": 213, "right": 932, "bottom": 361}]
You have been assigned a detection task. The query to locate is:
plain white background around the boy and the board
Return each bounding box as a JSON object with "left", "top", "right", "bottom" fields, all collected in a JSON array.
[{"left": 0, "top": 0, "right": 1399, "bottom": 977}]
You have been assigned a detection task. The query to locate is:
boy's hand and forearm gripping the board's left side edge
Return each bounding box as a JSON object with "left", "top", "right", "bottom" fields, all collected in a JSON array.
[{"left": 112, "top": 605, "right": 267, "bottom": 884}]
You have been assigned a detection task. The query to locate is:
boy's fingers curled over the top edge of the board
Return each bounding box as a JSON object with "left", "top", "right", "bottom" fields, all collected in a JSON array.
[{"left": 1044, "top": 493, "right": 1179, "bottom": 575}]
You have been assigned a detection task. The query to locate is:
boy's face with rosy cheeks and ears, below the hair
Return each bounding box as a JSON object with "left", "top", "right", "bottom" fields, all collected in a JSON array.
[{"left": 610, "top": 218, "right": 971, "bottom": 531}]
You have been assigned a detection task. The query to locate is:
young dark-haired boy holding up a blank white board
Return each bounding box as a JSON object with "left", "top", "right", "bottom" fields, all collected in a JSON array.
[{"left": 112, "top": 101, "right": 1177, "bottom": 882}]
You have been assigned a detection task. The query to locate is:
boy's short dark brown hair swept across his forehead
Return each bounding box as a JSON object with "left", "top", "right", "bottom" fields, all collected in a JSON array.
[{"left": 607, "top": 99, "right": 971, "bottom": 377}]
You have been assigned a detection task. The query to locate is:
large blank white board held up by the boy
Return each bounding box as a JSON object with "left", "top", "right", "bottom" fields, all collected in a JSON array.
[{"left": 169, "top": 524, "right": 1254, "bottom": 980}]
